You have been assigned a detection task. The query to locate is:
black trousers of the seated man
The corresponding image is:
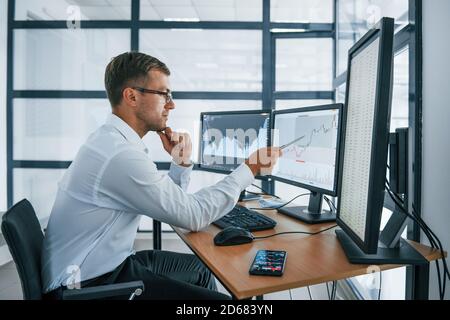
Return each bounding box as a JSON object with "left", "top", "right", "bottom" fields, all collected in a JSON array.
[{"left": 48, "top": 250, "right": 230, "bottom": 300}]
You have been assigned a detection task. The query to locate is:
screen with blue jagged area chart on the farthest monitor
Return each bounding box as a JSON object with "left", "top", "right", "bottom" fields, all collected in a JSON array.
[{"left": 199, "top": 110, "right": 270, "bottom": 172}]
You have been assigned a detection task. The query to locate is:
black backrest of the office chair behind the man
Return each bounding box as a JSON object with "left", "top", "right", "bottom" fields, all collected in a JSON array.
[{"left": 2, "top": 199, "right": 44, "bottom": 300}]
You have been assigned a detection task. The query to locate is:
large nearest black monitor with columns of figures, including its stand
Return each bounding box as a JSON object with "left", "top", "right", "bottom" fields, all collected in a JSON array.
[{"left": 336, "top": 18, "right": 423, "bottom": 264}]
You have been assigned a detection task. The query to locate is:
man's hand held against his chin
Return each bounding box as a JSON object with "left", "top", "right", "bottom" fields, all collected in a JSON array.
[{"left": 156, "top": 127, "right": 192, "bottom": 167}]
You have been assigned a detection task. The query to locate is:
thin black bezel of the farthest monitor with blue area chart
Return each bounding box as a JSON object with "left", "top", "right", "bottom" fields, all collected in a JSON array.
[{"left": 197, "top": 109, "right": 272, "bottom": 180}]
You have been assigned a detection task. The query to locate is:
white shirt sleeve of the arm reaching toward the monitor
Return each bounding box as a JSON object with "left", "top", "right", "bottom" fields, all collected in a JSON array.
[{"left": 95, "top": 151, "right": 254, "bottom": 231}]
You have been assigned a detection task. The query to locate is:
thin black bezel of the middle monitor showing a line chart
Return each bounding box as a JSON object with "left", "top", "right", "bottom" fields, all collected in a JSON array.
[{"left": 270, "top": 103, "right": 343, "bottom": 197}]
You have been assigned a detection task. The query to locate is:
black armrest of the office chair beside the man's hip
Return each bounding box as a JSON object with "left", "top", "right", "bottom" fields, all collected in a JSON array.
[{"left": 62, "top": 281, "right": 144, "bottom": 300}]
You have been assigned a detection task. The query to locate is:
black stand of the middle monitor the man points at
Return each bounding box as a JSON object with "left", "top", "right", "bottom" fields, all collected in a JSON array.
[{"left": 278, "top": 192, "right": 336, "bottom": 224}]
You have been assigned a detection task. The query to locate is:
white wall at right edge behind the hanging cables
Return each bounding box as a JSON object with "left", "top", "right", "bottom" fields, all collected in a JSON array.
[{"left": 422, "top": 0, "right": 450, "bottom": 299}]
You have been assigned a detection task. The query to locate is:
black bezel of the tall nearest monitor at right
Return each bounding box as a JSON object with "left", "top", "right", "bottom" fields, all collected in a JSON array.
[{"left": 336, "top": 18, "right": 394, "bottom": 254}]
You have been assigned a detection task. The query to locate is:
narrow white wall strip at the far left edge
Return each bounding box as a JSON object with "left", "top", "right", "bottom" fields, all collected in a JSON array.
[{"left": 0, "top": 1, "right": 8, "bottom": 211}]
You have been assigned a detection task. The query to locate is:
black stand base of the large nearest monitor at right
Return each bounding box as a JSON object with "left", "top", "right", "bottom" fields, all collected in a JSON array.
[{"left": 336, "top": 230, "right": 428, "bottom": 265}]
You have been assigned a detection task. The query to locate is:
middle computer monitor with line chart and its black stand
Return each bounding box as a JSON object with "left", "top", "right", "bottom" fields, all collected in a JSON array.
[{"left": 271, "top": 104, "right": 342, "bottom": 223}]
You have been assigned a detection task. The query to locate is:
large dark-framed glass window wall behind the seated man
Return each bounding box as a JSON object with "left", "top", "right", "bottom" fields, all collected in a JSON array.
[{"left": 7, "top": 0, "right": 334, "bottom": 230}]
